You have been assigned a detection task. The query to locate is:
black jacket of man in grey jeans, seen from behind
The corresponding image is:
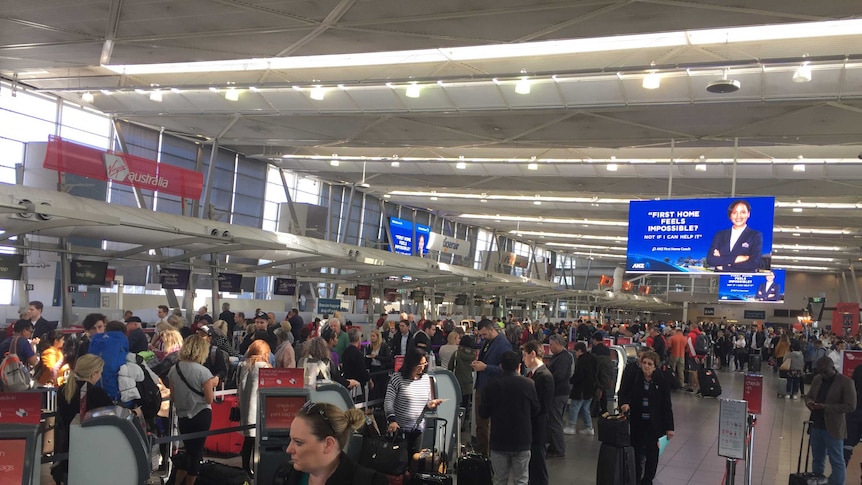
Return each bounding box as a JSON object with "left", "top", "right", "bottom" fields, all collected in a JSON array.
[{"left": 478, "top": 368, "right": 540, "bottom": 451}]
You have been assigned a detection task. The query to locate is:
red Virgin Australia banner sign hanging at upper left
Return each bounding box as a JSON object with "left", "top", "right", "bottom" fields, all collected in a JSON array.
[{"left": 42, "top": 136, "right": 204, "bottom": 199}]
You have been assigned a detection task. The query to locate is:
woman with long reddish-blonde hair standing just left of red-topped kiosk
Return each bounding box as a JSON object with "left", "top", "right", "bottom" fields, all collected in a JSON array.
[{"left": 237, "top": 340, "right": 271, "bottom": 476}]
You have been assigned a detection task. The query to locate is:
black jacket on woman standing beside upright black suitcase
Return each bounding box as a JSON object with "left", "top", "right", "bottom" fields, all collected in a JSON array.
[{"left": 619, "top": 370, "right": 674, "bottom": 438}]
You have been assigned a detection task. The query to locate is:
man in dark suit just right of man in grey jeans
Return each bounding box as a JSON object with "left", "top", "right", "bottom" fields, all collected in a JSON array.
[{"left": 521, "top": 340, "right": 554, "bottom": 485}]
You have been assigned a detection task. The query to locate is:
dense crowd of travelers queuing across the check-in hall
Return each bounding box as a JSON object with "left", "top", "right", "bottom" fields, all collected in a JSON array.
[{"left": 8, "top": 302, "right": 862, "bottom": 485}]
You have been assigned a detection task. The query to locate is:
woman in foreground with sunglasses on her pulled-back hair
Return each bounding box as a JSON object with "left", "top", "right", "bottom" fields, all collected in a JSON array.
[{"left": 275, "top": 401, "right": 388, "bottom": 485}]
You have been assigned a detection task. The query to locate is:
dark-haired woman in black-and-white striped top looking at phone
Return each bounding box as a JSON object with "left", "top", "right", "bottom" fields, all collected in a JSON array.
[{"left": 383, "top": 347, "right": 443, "bottom": 456}]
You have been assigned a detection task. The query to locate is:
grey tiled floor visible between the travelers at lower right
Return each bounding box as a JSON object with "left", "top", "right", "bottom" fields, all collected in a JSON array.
[{"left": 42, "top": 368, "right": 862, "bottom": 485}]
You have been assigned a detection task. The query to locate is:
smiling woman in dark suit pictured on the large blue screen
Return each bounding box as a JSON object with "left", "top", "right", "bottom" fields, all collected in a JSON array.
[{"left": 706, "top": 200, "right": 763, "bottom": 273}]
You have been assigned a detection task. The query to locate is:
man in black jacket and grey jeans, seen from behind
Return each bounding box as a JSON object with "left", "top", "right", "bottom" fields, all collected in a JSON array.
[{"left": 477, "top": 350, "right": 541, "bottom": 483}]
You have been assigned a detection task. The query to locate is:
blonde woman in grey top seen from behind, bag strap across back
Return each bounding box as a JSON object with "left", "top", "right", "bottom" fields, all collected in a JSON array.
[{"left": 168, "top": 334, "right": 218, "bottom": 485}]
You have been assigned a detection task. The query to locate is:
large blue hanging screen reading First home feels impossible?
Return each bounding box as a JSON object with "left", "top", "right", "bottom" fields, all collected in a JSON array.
[{"left": 626, "top": 197, "right": 775, "bottom": 274}]
